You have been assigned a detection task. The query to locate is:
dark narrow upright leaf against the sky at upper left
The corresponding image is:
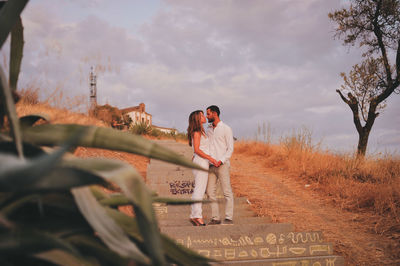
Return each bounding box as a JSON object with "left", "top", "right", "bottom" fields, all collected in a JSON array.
[{"left": 9, "top": 17, "right": 24, "bottom": 91}]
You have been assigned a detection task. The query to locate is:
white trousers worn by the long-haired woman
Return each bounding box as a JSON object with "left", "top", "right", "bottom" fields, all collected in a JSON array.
[{"left": 190, "top": 155, "right": 209, "bottom": 218}]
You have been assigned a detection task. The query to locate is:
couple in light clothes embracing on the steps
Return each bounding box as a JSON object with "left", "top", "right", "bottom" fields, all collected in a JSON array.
[{"left": 187, "top": 105, "right": 233, "bottom": 226}]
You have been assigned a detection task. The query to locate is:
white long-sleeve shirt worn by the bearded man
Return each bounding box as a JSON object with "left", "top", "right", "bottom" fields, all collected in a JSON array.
[{"left": 207, "top": 121, "right": 233, "bottom": 164}]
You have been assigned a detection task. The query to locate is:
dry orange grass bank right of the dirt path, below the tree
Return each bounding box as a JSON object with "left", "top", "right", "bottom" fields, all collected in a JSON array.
[{"left": 235, "top": 139, "right": 400, "bottom": 233}]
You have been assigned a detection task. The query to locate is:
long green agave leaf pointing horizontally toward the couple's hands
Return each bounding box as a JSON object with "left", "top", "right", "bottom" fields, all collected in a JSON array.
[{"left": 23, "top": 124, "right": 206, "bottom": 171}]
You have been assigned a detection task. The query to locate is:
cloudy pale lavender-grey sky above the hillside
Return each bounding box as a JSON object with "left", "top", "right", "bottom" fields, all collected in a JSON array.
[{"left": 2, "top": 0, "right": 400, "bottom": 153}]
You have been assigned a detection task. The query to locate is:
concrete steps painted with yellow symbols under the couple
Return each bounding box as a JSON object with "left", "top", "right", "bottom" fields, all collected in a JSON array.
[{"left": 147, "top": 140, "right": 344, "bottom": 266}]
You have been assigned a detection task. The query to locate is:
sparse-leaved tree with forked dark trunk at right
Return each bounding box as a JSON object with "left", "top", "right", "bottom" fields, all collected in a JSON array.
[{"left": 329, "top": 0, "right": 400, "bottom": 156}]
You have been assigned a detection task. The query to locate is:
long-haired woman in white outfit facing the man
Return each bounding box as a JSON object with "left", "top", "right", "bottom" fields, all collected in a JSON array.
[{"left": 187, "top": 110, "right": 217, "bottom": 226}]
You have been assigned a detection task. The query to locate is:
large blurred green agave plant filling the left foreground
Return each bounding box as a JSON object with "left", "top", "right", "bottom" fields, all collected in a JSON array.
[{"left": 0, "top": 0, "right": 208, "bottom": 265}]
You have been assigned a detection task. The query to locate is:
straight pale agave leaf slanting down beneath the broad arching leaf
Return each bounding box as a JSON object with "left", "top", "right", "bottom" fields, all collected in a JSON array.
[{"left": 72, "top": 187, "right": 150, "bottom": 264}]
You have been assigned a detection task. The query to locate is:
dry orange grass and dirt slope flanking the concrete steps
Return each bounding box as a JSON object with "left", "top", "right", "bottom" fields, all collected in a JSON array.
[{"left": 17, "top": 95, "right": 400, "bottom": 265}]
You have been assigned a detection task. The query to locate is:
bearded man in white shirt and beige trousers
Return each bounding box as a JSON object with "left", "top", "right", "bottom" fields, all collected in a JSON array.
[{"left": 207, "top": 105, "right": 233, "bottom": 225}]
